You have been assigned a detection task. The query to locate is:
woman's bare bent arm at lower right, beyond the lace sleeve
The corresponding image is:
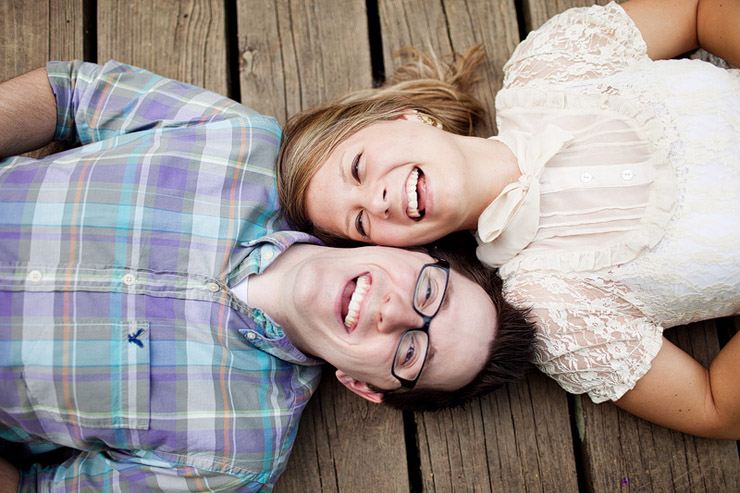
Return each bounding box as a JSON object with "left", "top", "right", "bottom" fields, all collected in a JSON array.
[{"left": 616, "top": 333, "right": 740, "bottom": 440}]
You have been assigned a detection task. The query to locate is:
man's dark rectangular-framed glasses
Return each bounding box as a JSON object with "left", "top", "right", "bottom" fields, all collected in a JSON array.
[{"left": 391, "top": 260, "right": 450, "bottom": 389}]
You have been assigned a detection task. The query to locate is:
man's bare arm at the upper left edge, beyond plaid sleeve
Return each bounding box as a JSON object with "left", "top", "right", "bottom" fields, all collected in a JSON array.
[{"left": 0, "top": 68, "right": 57, "bottom": 158}]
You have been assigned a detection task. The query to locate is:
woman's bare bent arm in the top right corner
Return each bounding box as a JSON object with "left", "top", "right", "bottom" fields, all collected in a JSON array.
[{"left": 621, "top": 0, "right": 740, "bottom": 66}]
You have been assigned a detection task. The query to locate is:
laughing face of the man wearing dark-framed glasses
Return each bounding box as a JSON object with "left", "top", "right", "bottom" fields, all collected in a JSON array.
[{"left": 281, "top": 246, "right": 497, "bottom": 396}]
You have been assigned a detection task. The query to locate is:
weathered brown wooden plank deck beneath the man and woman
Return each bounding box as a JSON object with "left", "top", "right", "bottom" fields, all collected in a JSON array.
[{"left": 0, "top": 0, "right": 740, "bottom": 493}]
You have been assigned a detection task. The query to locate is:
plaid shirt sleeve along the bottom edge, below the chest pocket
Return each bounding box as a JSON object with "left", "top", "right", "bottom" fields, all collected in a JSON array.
[{"left": 18, "top": 451, "right": 271, "bottom": 493}]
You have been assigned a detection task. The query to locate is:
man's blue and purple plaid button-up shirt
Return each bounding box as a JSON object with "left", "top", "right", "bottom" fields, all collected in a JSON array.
[{"left": 0, "top": 62, "right": 320, "bottom": 492}]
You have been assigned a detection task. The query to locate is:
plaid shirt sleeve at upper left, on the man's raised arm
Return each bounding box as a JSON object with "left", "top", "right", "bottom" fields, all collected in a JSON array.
[{"left": 46, "top": 60, "right": 257, "bottom": 144}]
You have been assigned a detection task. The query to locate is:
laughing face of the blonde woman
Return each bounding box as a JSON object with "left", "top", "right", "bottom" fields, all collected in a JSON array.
[{"left": 306, "top": 112, "right": 470, "bottom": 246}]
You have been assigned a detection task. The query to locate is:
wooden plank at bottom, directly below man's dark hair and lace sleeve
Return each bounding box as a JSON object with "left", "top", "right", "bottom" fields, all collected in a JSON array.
[{"left": 417, "top": 372, "right": 578, "bottom": 492}]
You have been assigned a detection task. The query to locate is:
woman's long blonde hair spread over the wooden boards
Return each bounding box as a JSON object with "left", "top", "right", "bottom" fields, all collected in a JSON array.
[{"left": 277, "top": 44, "right": 485, "bottom": 244}]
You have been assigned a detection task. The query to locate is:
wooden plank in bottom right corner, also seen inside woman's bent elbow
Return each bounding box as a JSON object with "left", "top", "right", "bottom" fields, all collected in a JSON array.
[{"left": 581, "top": 321, "right": 740, "bottom": 492}]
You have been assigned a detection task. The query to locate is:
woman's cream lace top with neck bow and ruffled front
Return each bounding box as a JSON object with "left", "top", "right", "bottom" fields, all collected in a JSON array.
[{"left": 477, "top": 3, "right": 740, "bottom": 402}]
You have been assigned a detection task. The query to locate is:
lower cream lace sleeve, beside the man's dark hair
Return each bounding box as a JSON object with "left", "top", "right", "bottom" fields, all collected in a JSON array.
[{"left": 505, "top": 274, "right": 663, "bottom": 403}]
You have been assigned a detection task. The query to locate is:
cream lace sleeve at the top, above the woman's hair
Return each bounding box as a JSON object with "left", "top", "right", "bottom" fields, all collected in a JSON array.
[{"left": 504, "top": 2, "right": 649, "bottom": 88}]
